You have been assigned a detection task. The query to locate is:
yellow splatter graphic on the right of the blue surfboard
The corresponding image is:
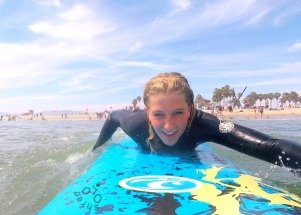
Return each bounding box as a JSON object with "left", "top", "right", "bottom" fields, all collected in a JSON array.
[{"left": 191, "top": 167, "right": 301, "bottom": 215}]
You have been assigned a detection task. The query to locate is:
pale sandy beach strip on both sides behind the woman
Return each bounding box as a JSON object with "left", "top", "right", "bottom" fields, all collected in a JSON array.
[{"left": 0, "top": 108, "right": 301, "bottom": 122}]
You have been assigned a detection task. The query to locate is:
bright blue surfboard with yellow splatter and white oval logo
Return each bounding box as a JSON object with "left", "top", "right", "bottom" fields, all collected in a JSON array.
[{"left": 39, "top": 138, "right": 301, "bottom": 215}]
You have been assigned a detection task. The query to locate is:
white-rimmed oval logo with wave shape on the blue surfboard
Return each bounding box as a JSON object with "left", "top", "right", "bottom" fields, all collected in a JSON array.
[{"left": 119, "top": 175, "right": 201, "bottom": 193}]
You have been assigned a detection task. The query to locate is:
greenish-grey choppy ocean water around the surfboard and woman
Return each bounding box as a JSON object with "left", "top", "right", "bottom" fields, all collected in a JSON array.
[{"left": 0, "top": 117, "right": 301, "bottom": 215}]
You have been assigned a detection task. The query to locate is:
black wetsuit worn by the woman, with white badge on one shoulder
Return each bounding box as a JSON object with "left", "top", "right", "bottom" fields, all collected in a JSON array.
[{"left": 93, "top": 109, "right": 301, "bottom": 169}]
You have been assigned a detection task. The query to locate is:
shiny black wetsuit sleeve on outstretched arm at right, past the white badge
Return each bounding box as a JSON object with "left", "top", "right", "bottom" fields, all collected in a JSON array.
[{"left": 212, "top": 124, "right": 301, "bottom": 169}]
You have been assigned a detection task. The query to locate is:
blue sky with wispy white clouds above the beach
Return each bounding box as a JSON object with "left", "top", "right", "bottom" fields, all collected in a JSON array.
[{"left": 0, "top": 0, "right": 301, "bottom": 113}]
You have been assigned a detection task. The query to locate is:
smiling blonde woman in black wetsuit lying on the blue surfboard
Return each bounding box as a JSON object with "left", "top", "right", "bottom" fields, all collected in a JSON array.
[{"left": 93, "top": 72, "right": 301, "bottom": 169}]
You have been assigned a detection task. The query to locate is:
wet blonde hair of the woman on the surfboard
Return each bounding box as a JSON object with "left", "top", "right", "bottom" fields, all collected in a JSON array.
[{"left": 143, "top": 72, "right": 194, "bottom": 146}]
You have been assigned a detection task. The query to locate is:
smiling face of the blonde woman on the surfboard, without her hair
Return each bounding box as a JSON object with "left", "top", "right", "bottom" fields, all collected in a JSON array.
[{"left": 146, "top": 92, "right": 190, "bottom": 146}]
